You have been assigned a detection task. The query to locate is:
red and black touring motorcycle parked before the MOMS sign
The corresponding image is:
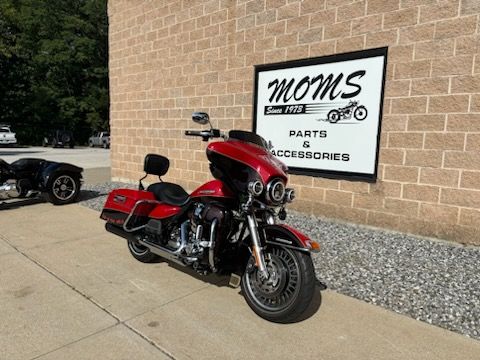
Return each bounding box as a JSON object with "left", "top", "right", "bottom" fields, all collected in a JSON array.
[{"left": 101, "top": 113, "right": 319, "bottom": 323}]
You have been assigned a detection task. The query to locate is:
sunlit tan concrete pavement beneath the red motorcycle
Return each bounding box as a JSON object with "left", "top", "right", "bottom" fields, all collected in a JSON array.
[{"left": 0, "top": 203, "right": 480, "bottom": 360}]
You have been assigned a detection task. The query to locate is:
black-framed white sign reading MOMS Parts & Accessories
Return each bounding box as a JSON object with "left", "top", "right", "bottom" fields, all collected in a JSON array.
[{"left": 253, "top": 48, "right": 387, "bottom": 182}]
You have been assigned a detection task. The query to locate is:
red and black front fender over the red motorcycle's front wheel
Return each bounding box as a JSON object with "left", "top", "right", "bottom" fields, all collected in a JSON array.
[{"left": 260, "top": 224, "right": 320, "bottom": 252}]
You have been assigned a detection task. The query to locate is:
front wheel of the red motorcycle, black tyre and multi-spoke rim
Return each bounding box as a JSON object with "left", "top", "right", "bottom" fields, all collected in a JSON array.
[{"left": 242, "top": 247, "right": 315, "bottom": 323}]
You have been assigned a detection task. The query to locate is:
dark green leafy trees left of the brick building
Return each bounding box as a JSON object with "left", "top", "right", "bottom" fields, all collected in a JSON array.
[{"left": 0, "top": 0, "right": 109, "bottom": 143}]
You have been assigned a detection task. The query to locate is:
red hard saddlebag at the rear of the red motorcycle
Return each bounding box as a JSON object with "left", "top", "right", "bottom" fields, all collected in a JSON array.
[{"left": 100, "top": 189, "right": 158, "bottom": 228}]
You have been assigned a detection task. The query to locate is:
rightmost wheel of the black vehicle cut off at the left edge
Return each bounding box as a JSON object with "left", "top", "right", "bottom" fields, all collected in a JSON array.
[{"left": 46, "top": 173, "right": 80, "bottom": 205}]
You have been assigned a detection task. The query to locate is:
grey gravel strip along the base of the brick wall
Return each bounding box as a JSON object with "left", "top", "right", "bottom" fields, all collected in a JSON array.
[{"left": 80, "top": 183, "right": 480, "bottom": 339}]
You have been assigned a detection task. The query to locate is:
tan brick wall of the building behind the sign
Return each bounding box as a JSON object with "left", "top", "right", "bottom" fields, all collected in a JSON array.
[{"left": 109, "top": 0, "right": 480, "bottom": 245}]
